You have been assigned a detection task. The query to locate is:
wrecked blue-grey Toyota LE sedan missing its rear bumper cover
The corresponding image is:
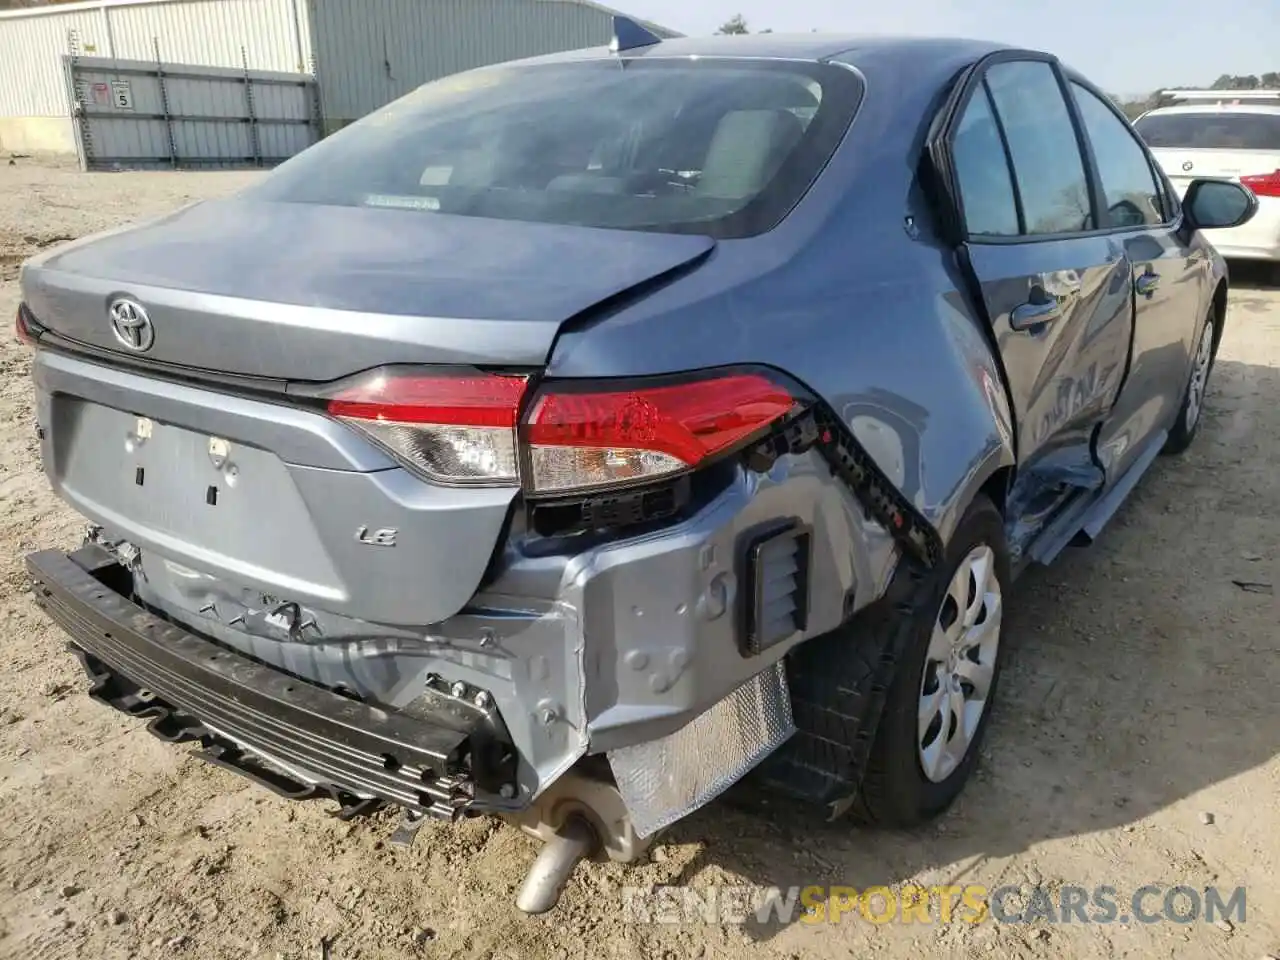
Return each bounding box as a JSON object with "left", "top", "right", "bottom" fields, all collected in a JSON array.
[{"left": 18, "top": 20, "right": 1257, "bottom": 911}]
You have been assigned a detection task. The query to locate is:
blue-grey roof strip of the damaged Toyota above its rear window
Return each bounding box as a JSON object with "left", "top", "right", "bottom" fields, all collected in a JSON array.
[{"left": 506, "top": 33, "right": 1012, "bottom": 67}]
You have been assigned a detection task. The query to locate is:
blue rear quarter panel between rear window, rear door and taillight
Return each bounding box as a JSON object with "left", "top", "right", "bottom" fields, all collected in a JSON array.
[{"left": 548, "top": 47, "right": 1014, "bottom": 555}]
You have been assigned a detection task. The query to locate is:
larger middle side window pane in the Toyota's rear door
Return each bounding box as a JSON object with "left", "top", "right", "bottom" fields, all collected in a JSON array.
[{"left": 987, "top": 60, "right": 1094, "bottom": 234}]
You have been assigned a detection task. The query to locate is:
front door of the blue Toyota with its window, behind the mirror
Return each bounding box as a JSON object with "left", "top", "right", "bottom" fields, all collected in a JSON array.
[{"left": 1068, "top": 78, "right": 1212, "bottom": 481}]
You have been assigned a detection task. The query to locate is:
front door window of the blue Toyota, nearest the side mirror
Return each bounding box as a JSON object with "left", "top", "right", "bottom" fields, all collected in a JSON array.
[{"left": 1071, "top": 83, "right": 1165, "bottom": 227}]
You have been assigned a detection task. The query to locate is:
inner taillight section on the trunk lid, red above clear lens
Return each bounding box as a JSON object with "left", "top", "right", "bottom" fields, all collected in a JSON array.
[{"left": 328, "top": 370, "right": 527, "bottom": 484}]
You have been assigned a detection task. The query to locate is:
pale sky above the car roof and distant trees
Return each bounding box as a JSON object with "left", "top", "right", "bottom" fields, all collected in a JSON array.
[{"left": 627, "top": 0, "right": 1280, "bottom": 95}]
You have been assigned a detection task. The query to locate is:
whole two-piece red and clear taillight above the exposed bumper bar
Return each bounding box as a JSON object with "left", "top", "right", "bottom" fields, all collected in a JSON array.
[{"left": 326, "top": 367, "right": 796, "bottom": 495}]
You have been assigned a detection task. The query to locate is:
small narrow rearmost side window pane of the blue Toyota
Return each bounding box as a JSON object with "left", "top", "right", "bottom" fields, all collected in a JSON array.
[{"left": 951, "top": 87, "right": 1018, "bottom": 237}]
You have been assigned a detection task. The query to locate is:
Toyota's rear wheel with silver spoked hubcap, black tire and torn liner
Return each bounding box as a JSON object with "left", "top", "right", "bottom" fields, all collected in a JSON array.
[{"left": 753, "top": 495, "right": 1009, "bottom": 827}]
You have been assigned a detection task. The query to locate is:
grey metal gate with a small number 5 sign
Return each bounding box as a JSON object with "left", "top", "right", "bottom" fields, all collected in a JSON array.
[{"left": 63, "top": 47, "right": 320, "bottom": 170}]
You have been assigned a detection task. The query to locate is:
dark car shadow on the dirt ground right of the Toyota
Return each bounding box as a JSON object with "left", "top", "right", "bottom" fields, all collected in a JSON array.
[{"left": 645, "top": 316, "right": 1280, "bottom": 941}]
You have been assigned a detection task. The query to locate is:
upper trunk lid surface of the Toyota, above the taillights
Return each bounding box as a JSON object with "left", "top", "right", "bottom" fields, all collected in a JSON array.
[{"left": 23, "top": 198, "right": 714, "bottom": 381}]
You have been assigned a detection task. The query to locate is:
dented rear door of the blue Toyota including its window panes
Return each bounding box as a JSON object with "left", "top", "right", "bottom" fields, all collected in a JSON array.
[{"left": 947, "top": 54, "right": 1133, "bottom": 506}]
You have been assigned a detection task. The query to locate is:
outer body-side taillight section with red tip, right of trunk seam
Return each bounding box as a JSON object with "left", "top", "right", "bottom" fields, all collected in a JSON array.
[{"left": 524, "top": 374, "right": 795, "bottom": 493}]
